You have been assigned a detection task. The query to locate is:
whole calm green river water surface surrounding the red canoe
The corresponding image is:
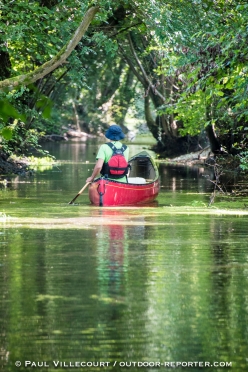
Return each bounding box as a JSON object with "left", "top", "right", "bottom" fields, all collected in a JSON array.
[{"left": 0, "top": 142, "right": 248, "bottom": 372}]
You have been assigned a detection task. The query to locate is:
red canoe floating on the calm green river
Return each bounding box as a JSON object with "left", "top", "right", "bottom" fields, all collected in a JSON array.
[{"left": 89, "top": 151, "right": 159, "bottom": 206}]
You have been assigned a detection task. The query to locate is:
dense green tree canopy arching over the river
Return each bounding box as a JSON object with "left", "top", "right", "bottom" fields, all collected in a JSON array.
[{"left": 0, "top": 0, "right": 248, "bottom": 155}]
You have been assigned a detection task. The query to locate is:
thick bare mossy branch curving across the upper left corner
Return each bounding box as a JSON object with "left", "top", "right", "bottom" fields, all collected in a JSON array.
[{"left": 0, "top": 6, "right": 99, "bottom": 90}]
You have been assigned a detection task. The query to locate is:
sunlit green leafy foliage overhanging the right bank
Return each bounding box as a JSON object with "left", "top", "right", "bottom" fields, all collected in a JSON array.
[{"left": 154, "top": 0, "right": 248, "bottom": 153}]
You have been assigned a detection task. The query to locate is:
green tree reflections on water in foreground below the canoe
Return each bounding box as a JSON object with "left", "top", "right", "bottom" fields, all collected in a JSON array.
[{"left": 0, "top": 208, "right": 248, "bottom": 372}]
